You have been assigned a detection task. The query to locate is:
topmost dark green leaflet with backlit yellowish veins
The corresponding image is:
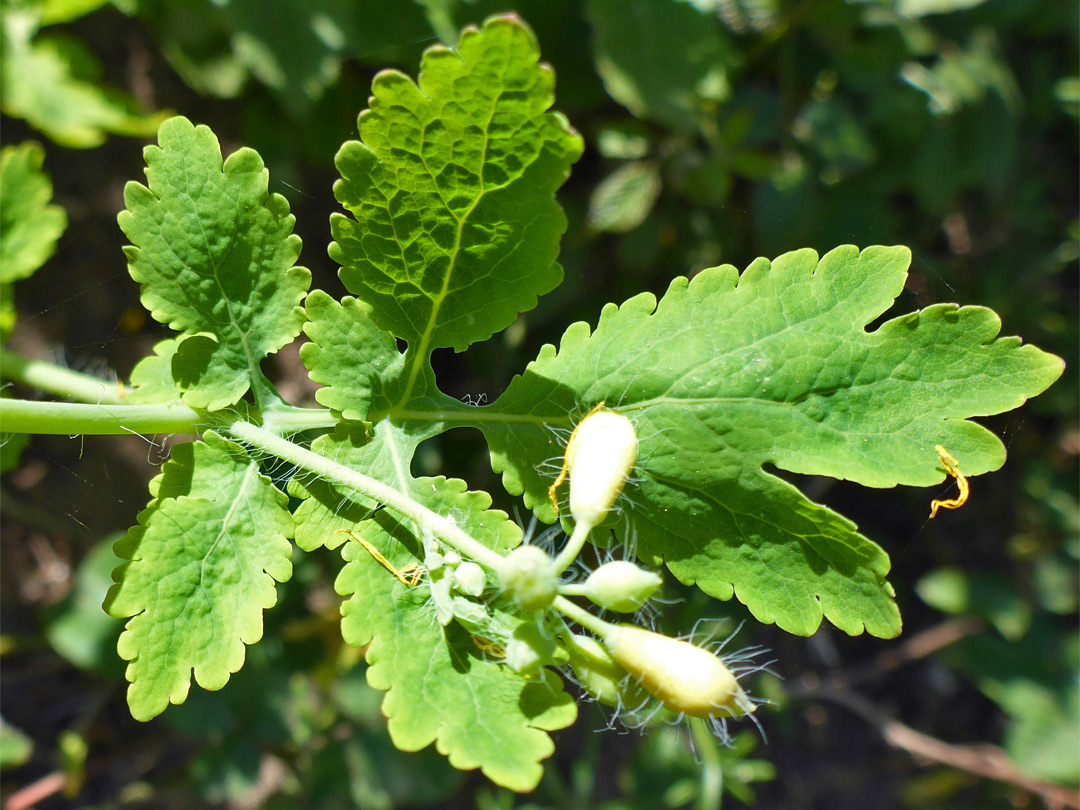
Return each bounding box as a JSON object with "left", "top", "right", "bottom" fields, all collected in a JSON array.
[{"left": 330, "top": 16, "right": 582, "bottom": 371}]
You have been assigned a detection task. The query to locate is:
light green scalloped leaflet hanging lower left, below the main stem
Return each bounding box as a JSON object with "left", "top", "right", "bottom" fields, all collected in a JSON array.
[{"left": 105, "top": 432, "right": 293, "bottom": 720}]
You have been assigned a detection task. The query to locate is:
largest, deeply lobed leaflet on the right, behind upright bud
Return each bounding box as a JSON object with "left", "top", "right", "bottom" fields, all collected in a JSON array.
[{"left": 471, "top": 245, "right": 1063, "bottom": 637}]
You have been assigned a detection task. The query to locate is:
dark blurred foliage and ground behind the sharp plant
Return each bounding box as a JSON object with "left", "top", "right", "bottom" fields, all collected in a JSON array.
[{"left": 0, "top": 0, "right": 1080, "bottom": 810}]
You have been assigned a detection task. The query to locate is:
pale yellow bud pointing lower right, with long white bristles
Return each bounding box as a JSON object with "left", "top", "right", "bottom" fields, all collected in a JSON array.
[{"left": 603, "top": 624, "right": 755, "bottom": 717}]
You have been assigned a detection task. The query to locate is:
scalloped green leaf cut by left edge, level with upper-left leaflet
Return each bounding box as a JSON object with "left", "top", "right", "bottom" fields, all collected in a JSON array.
[{"left": 0, "top": 141, "right": 67, "bottom": 284}]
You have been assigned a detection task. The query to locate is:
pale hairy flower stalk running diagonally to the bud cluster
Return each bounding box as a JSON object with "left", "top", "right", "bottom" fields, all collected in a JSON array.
[{"left": 228, "top": 421, "right": 504, "bottom": 575}]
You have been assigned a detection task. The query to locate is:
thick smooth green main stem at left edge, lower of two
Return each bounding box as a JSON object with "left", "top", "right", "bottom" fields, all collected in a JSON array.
[{"left": 0, "top": 399, "right": 211, "bottom": 436}]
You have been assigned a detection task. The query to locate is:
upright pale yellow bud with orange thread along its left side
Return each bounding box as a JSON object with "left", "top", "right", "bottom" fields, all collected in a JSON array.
[{"left": 566, "top": 408, "right": 637, "bottom": 527}]
